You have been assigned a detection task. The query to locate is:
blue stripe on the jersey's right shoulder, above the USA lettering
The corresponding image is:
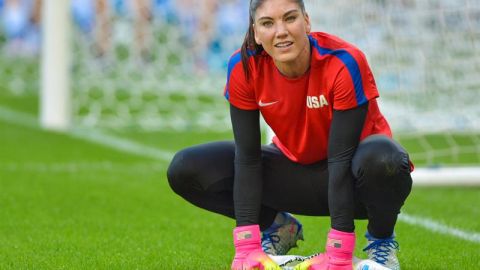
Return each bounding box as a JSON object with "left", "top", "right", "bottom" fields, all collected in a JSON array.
[{"left": 308, "top": 35, "right": 367, "bottom": 105}]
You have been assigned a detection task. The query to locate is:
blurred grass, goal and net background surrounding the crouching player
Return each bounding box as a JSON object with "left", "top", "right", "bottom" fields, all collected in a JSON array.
[{"left": 0, "top": 0, "right": 480, "bottom": 269}]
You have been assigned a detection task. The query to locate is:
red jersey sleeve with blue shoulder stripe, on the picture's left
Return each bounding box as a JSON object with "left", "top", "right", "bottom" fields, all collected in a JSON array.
[{"left": 224, "top": 51, "right": 258, "bottom": 110}]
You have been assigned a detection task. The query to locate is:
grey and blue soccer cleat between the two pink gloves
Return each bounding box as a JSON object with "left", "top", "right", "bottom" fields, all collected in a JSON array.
[{"left": 262, "top": 212, "right": 303, "bottom": 255}]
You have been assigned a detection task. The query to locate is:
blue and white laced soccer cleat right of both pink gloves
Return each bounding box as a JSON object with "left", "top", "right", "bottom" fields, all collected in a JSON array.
[{"left": 363, "top": 232, "right": 400, "bottom": 270}]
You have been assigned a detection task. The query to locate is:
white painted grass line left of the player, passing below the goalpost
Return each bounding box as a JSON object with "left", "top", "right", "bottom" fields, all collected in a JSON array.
[{"left": 0, "top": 106, "right": 174, "bottom": 162}]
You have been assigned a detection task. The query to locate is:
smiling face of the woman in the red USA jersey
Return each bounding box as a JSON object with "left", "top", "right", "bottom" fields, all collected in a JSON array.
[{"left": 253, "top": 0, "right": 311, "bottom": 68}]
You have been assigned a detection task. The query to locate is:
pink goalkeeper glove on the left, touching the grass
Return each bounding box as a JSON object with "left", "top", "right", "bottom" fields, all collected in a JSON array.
[{"left": 232, "top": 225, "right": 281, "bottom": 270}]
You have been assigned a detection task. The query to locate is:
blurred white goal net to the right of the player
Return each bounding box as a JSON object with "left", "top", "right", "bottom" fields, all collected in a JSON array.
[{"left": 308, "top": 0, "right": 480, "bottom": 169}]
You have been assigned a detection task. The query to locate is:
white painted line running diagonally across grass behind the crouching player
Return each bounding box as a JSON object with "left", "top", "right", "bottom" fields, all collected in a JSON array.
[{"left": 0, "top": 106, "right": 480, "bottom": 243}]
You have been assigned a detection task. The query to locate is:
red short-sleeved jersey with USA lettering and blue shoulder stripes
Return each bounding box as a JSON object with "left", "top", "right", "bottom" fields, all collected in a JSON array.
[{"left": 224, "top": 32, "right": 392, "bottom": 164}]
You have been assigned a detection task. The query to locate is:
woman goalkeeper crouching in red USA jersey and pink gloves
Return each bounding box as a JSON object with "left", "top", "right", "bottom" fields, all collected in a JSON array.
[{"left": 168, "top": 0, "right": 413, "bottom": 270}]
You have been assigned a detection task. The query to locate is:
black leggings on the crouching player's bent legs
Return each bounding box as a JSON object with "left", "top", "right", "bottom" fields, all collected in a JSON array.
[{"left": 167, "top": 135, "right": 412, "bottom": 238}]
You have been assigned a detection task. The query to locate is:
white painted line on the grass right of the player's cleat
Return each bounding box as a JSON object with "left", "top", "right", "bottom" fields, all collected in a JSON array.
[{"left": 398, "top": 213, "right": 480, "bottom": 243}]
